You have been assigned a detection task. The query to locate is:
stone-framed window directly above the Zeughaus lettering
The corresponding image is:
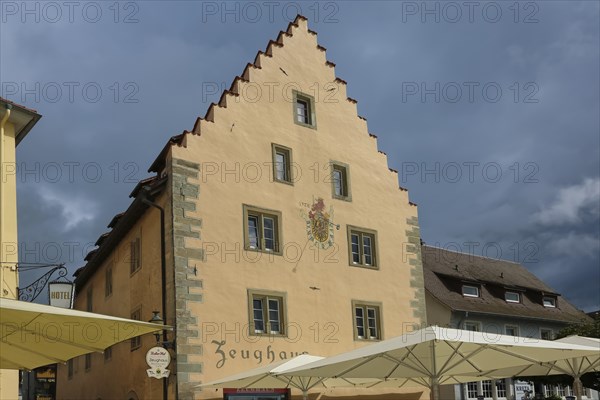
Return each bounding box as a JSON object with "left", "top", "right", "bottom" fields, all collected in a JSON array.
[{"left": 248, "top": 290, "right": 286, "bottom": 336}]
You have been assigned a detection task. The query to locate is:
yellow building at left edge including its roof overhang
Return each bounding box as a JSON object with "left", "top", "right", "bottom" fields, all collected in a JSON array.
[{"left": 0, "top": 97, "right": 41, "bottom": 400}]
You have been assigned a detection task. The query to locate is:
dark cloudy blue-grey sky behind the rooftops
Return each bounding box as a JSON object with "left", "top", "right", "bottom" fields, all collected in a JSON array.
[{"left": 0, "top": 1, "right": 600, "bottom": 311}]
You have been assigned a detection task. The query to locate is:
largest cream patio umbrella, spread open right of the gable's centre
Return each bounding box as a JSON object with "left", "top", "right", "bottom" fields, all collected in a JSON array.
[{"left": 283, "top": 326, "right": 594, "bottom": 400}]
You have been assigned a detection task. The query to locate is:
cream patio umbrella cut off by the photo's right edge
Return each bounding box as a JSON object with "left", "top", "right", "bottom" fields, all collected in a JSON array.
[{"left": 468, "top": 335, "right": 600, "bottom": 400}]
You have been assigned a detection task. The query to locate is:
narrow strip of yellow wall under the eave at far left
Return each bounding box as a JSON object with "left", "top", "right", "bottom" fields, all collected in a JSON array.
[{"left": 0, "top": 117, "right": 19, "bottom": 400}]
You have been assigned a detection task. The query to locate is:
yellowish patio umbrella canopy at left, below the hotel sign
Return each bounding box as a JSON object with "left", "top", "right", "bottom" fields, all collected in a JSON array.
[{"left": 0, "top": 298, "right": 171, "bottom": 369}]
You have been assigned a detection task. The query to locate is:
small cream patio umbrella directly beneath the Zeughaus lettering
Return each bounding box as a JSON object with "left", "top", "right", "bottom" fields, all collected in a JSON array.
[{"left": 198, "top": 354, "right": 377, "bottom": 399}]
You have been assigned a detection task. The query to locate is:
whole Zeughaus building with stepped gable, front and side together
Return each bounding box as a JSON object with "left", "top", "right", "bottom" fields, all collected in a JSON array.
[{"left": 58, "top": 16, "right": 428, "bottom": 400}]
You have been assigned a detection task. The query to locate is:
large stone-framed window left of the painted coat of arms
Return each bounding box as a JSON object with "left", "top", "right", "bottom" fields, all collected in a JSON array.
[{"left": 244, "top": 205, "right": 281, "bottom": 254}]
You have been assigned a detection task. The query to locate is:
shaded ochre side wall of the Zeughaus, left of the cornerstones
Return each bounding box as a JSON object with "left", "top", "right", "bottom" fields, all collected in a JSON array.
[{"left": 57, "top": 195, "right": 174, "bottom": 400}]
